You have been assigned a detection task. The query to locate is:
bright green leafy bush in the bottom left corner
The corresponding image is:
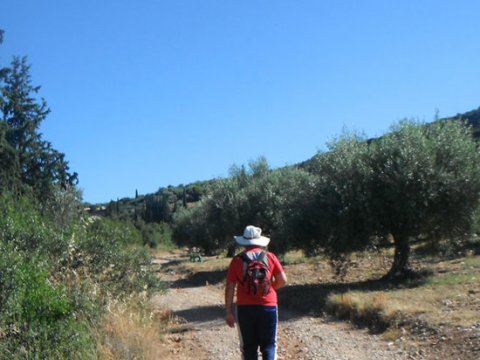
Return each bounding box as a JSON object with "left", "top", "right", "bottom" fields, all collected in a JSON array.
[{"left": 0, "top": 243, "right": 95, "bottom": 359}]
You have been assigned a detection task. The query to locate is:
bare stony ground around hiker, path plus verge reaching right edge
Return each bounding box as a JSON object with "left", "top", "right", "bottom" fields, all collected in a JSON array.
[{"left": 153, "top": 253, "right": 480, "bottom": 360}]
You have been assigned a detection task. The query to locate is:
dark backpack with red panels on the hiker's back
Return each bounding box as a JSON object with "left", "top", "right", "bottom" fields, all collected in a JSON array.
[{"left": 238, "top": 251, "right": 271, "bottom": 297}]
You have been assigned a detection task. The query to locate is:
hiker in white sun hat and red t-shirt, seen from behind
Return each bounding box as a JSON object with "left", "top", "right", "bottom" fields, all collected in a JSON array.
[{"left": 225, "top": 225, "right": 287, "bottom": 360}]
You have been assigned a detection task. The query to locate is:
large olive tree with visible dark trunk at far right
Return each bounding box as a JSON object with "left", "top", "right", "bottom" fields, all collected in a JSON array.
[{"left": 369, "top": 120, "right": 480, "bottom": 277}]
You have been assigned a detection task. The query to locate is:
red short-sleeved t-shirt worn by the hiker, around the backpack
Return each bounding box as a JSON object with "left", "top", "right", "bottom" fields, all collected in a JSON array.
[{"left": 227, "top": 247, "right": 283, "bottom": 306}]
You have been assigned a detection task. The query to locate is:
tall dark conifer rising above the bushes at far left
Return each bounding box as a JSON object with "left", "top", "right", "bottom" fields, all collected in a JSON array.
[{"left": 0, "top": 57, "right": 77, "bottom": 199}]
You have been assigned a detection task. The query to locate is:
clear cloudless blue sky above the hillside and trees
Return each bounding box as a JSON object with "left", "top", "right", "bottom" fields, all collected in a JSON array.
[{"left": 0, "top": 0, "right": 480, "bottom": 203}]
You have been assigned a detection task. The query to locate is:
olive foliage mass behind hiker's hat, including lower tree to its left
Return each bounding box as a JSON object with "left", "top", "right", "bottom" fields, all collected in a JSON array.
[{"left": 173, "top": 158, "right": 312, "bottom": 253}]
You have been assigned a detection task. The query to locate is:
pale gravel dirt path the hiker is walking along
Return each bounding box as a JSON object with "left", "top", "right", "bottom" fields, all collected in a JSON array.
[{"left": 154, "top": 258, "right": 416, "bottom": 360}]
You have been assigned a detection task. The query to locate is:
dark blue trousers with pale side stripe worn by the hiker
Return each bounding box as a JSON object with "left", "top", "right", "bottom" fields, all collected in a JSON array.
[{"left": 237, "top": 305, "right": 278, "bottom": 360}]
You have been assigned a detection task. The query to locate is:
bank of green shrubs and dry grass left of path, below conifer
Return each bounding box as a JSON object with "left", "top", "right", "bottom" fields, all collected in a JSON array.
[{"left": 0, "top": 195, "right": 160, "bottom": 359}]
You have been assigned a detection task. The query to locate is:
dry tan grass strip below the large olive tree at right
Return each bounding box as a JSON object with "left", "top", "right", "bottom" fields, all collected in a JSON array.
[{"left": 326, "top": 256, "right": 480, "bottom": 337}]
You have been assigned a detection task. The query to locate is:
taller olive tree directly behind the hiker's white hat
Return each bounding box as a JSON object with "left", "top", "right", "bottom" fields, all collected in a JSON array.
[{"left": 207, "top": 158, "right": 313, "bottom": 254}]
